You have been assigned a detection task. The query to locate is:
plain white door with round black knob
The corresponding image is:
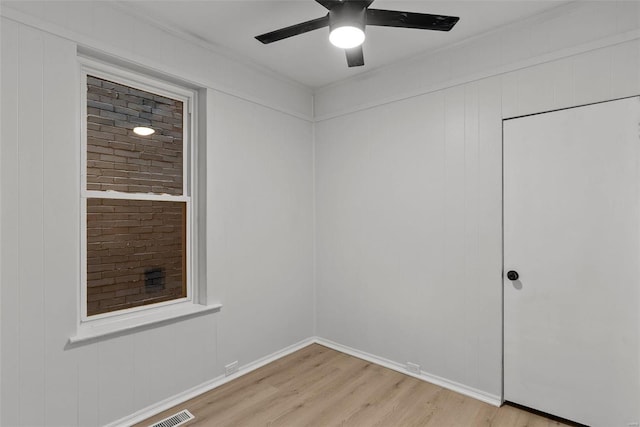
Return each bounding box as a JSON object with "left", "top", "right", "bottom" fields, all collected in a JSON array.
[{"left": 503, "top": 98, "right": 640, "bottom": 427}]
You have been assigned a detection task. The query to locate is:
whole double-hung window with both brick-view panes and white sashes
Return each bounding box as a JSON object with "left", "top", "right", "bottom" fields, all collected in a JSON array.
[{"left": 81, "top": 64, "right": 196, "bottom": 321}]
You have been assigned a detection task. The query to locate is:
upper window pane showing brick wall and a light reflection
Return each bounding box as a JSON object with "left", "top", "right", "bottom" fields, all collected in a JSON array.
[{"left": 87, "top": 76, "right": 183, "bottom": 195}]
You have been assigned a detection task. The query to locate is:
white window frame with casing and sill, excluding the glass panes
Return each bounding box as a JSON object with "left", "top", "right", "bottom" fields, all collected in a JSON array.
[{"left": 70, "top": 57, "right": 221, "bottom": 343}]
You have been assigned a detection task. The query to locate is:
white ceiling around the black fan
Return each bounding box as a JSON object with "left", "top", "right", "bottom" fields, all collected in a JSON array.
[{"left": 119, "top": 0, "right": 568, "bottom": 88}]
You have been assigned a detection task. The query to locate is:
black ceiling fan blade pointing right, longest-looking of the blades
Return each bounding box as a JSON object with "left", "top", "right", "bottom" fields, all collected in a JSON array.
[{"left": 367, "top": 9, "right": 460, "bottom": 31}]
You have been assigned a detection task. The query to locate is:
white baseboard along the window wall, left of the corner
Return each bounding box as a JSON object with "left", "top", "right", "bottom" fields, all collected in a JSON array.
[{"left": 105, "top": 337, "right": 315, "bottom": 427}]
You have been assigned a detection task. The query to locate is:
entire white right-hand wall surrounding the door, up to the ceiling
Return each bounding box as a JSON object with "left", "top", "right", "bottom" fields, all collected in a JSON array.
[{"left": 315, "top": 2, "right": 640, "bottom": 399}]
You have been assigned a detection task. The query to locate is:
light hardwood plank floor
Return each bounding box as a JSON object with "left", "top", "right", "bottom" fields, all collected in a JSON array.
[{"left": 138, "top": 344, "right": 567, "bottom": 427}]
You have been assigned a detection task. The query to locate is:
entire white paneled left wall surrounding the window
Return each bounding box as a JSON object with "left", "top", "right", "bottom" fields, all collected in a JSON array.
[{"left": 0, "top": 2, "right": 314, "bottom": 426}]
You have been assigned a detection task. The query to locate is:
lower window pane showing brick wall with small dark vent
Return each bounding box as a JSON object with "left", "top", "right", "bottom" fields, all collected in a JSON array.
[{"left": 87, "top": 199, "right": 186, "bottom": 316}]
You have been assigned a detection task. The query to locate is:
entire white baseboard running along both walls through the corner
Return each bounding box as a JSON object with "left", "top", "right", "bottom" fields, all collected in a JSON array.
[{"left": 105, "top": 337, "right": 502, "bottom": 427}]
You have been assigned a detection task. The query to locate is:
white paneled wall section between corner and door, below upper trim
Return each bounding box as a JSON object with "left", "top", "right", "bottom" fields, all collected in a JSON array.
[{"left": 316, "top": 78, "right": 502, "bottom": 395}]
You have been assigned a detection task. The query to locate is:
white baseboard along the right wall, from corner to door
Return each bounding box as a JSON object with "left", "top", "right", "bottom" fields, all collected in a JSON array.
[{"left": 315, "top": 337, "right": 502, "bottom": 406}]
